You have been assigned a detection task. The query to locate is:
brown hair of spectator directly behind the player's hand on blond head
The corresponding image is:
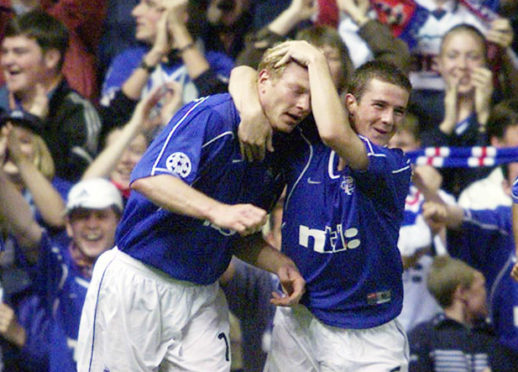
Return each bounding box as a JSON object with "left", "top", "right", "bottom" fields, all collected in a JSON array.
[{"left": 295, "top": 26, "right": 354, "bottom": 91}]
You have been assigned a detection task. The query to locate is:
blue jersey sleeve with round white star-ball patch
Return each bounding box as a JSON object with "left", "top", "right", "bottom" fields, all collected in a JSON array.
[{"left": 131, "top": 98, "right": 225, "bottom": 185}]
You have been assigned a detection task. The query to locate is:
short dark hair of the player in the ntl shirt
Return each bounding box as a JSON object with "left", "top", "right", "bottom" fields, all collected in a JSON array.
[{"left": 347, "top": 60, "right": 412, "bottom": 101}]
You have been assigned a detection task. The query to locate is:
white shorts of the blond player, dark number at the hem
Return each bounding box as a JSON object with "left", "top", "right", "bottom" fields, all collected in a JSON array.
[{"left": 77, "top": 248, "right": 230, "bottom": 372}]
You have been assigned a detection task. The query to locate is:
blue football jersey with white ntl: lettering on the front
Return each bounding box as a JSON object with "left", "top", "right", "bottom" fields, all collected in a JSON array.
[{"left": 282, "top": 124, "right": 411, "bottom": 329}]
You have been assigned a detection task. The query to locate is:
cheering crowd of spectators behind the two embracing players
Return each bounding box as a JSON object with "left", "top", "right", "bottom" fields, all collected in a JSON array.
[{"left": 0, "top": 0, "right": 518, "bottom": 372}]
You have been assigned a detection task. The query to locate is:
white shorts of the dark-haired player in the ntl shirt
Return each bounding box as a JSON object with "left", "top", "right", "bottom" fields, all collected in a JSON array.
[{"left": 264, "top": 305, "right": 408, "bottom": 372}]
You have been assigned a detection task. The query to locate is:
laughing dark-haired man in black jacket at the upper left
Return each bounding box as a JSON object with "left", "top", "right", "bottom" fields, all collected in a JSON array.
[{"left": 0, "top": 10, "right": 101, "bottom": 182}]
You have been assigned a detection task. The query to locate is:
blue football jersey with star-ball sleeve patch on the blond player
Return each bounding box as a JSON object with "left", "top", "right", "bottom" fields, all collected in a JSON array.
[{"left": 116, "top": 94, "right": 282, "bottom": 284}]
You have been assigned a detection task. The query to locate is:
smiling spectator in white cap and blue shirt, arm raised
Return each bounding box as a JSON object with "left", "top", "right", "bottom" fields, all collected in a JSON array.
[{"left": 0, "top": 175, "right": 123, "bottom": 371}]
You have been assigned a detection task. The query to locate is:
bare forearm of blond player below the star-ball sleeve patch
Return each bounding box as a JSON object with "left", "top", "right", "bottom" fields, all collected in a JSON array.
[{"left": 131, "top": 175, "right": 222, "bottom": 222}]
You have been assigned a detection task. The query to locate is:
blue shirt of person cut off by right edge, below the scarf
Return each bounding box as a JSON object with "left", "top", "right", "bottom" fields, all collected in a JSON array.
[{"left": 448, "top": 206, "right": 518, "bottom": 351}]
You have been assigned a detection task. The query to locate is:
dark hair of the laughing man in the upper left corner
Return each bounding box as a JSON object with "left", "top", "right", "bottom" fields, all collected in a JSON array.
[{"left": 4, "top": 9, "right": 69, "bottom": 70}]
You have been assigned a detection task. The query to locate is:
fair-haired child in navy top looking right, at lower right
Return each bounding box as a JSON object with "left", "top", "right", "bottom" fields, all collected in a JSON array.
[{"left": 408, "top": 256, "right": 499, "bottom": 372}]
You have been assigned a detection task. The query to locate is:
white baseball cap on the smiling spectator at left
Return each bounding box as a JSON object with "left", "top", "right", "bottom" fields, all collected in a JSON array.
[{"left": 65, "top": 178, "right": 124, "bottom": 214}]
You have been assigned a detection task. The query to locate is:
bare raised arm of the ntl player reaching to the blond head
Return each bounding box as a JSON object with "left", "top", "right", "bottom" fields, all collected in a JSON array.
[{"left": 308, "top": 57, "right": 368, "bottom": 169}]
